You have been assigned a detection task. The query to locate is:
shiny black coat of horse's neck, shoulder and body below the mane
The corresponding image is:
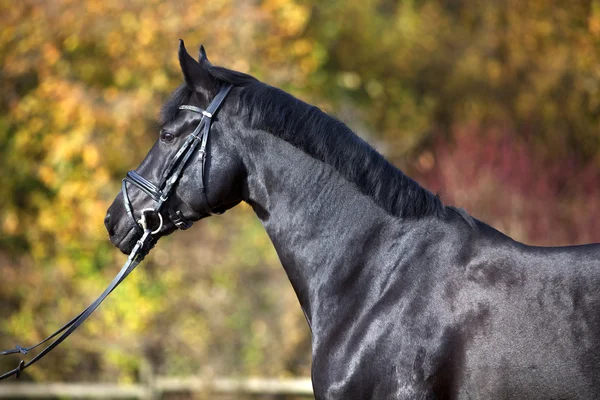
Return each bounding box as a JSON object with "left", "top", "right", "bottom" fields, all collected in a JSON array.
[{"left": 244, "top": 130, "right": 600, "bottom": 399}]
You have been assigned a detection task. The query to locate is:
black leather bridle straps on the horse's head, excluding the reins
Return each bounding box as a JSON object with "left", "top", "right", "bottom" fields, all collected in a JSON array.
[{"left": 121, "top": 85, "right": 231, "bottom": 231}]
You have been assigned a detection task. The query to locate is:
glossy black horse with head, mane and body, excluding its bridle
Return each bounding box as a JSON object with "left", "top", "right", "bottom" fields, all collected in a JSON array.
[{"left": 105, "top": 42, "right": 600, "bottom": 399}]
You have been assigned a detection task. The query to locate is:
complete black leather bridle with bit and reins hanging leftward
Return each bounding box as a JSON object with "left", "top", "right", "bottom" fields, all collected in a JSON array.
[{"left": 0, "top": 85, "right": 232, "bottom": 380}]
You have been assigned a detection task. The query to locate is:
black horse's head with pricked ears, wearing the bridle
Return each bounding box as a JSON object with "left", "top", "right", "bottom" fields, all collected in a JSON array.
[{"left": 105, "top": 41, "right": 248, "bottom": 254}]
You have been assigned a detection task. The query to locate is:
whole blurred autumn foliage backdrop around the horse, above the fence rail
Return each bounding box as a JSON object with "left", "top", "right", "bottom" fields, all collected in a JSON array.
[{"left": 0, "top": 0, "right": 600, "bottom": 390}]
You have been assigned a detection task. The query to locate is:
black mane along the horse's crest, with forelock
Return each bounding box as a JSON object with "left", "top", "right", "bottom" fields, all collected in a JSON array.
[{"left": 161, "top": 66, "right": 446, "bottom": 218}]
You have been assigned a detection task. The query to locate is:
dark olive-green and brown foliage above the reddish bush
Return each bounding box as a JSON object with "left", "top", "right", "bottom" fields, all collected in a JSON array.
[{"left": 308, "top": 0, "right": 600, "bottom": 163}]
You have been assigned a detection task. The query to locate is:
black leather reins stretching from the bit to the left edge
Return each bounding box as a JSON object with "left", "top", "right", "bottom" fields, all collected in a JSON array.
[{"left": 0, "top": 215, "right": 155, "bottom": 380}]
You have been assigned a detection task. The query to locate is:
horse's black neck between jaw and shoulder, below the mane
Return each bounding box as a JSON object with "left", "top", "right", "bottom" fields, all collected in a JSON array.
[{"left": 237, "top": 132, "right": 397, "bottom": 321}]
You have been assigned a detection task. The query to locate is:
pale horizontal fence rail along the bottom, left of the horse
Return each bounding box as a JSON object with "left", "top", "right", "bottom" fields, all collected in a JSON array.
[{"left": 0, "top": 377, "right": 314, "bottom": 399}]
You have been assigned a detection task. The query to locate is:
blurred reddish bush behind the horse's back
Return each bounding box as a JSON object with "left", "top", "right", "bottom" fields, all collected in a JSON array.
[{"left": 416, "top": 125, "right": 600, "bottom": 246}]
